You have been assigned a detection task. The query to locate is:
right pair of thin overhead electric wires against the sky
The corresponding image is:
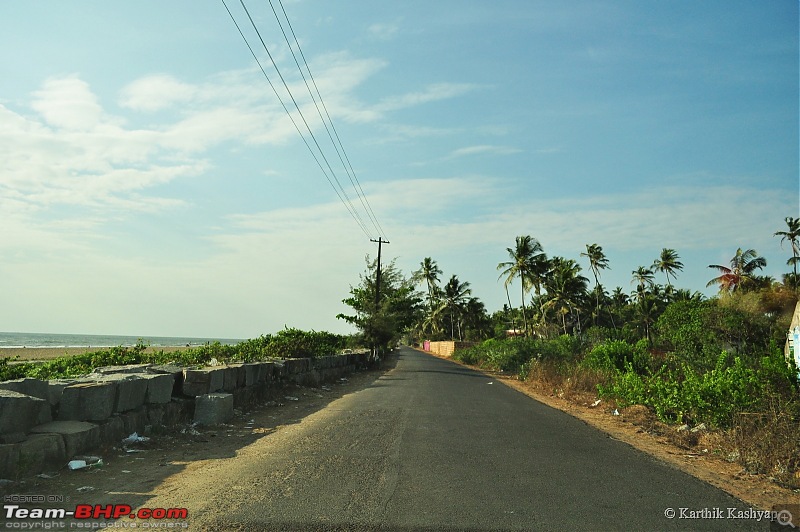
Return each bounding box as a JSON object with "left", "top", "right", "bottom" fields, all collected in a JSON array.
[{"left": 269, "top": 0, "right": 386, "bottom": 236}]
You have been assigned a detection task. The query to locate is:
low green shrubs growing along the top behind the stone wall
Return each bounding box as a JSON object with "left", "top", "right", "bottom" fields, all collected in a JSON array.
[{"left": 0, "top": 328, "right": 348, "bottom": 380}]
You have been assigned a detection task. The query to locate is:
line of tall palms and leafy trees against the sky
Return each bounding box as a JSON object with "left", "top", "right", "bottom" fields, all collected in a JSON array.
[{"left": 338, "top": 217, "right": 800, "bottom": 356}]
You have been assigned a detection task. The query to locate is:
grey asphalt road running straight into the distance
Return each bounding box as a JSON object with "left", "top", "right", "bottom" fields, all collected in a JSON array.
[{"left": 148, "top": 349, "right": 769, "bottom": 530}]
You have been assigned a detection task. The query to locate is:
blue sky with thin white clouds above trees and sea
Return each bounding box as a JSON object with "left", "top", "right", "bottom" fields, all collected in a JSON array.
[{"left": 0, "top": 0, "right": 800, "bottom": 338}]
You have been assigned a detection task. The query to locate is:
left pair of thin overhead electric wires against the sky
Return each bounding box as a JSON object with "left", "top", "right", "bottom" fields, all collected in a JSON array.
[{"left": 222, "top": 0, "right": 371, "bottom": 238}]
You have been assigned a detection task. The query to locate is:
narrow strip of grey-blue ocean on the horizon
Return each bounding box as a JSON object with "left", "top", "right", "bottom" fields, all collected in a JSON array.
[{"left": 0, "top": 332, "right": 242, "bottom": 349}]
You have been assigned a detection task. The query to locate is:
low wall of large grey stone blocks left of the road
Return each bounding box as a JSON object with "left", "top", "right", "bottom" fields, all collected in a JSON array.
[{"left": 0, "top": 353, "right": 369, "bottom": 479}]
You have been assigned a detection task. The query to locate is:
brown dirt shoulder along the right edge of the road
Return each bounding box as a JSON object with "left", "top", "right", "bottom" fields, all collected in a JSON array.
[{"left": 428, "top": 353, "right": 800, "bottom": 510}]
